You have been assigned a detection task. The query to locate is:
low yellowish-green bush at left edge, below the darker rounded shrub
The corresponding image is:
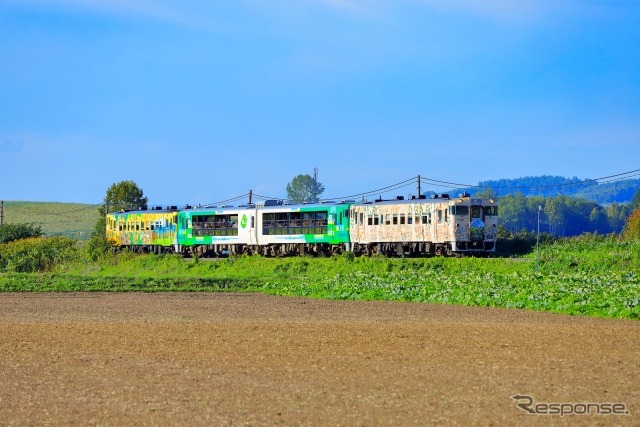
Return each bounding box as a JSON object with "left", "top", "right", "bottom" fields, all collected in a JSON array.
[{"left": 0, "top": 237, "right": 78, "bottom": 273}]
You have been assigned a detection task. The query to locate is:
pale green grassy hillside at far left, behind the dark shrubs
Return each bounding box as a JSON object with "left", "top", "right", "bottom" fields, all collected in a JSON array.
[{"left": 4, "top": 201, "right": 98, "bottom": 240}]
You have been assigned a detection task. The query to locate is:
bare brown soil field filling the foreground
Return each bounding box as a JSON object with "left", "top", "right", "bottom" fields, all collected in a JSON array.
[{"left": 0, "top": 293, "right": 640, "bottom": 426}]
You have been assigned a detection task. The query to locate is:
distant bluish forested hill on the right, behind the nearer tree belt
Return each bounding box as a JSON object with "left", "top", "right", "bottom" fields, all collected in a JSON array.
[{"left": 461, "top": 175, "right": 640, "bottom": 204}]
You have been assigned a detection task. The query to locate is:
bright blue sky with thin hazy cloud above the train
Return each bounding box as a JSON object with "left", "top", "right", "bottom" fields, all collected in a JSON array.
[{"left": 0, "top": 0, "right": 640, "bottom": 204}]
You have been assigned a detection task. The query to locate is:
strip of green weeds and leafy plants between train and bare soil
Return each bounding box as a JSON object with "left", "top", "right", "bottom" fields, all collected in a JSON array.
[{"left": 0, "top": 235, "right": 640, "bottom": 319}]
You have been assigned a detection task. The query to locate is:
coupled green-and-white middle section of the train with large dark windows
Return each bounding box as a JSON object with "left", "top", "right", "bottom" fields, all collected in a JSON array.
[{"left": 176, "top": 201, "right": 349, "bottom": 256}]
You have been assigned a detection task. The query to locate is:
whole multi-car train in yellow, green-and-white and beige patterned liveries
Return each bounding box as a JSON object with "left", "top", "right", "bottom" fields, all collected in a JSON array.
[{"left": 106, "top": 194, "right": 498, "bottom": 256}]
